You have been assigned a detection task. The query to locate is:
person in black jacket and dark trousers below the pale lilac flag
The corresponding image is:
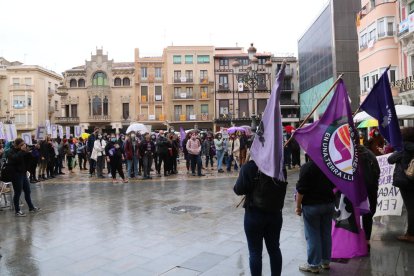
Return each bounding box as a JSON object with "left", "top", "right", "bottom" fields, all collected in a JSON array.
[{"left": 233, "top": 160, "right": 287, "bottom": 276}]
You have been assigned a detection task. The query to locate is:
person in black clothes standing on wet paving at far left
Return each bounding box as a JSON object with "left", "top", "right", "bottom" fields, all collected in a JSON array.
[{"left": 7, "top": 138, "right": 40, "bottom": 217}]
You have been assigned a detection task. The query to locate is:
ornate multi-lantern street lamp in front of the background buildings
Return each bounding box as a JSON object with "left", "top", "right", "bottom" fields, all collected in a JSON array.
[{"left": 232, "top": 43, "right": 272, "bottom": 132}]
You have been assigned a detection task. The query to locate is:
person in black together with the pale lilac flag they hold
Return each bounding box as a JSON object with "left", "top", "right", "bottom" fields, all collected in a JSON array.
[{"left": 233, "top": 61, "right": 287, "bottom": 276}]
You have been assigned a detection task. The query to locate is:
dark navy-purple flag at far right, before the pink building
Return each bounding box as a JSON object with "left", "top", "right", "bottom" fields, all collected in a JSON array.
[{"left": 361, "top": 69, "right": 403, "bottom": 151}]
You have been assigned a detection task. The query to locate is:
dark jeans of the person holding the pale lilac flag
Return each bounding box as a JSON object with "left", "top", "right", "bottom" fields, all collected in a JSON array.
[{"left": 244, "top": 209, "right": 283, "bottom": 276}]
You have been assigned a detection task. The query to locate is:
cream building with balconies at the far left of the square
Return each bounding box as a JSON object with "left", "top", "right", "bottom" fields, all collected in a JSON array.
[{"left": 0, "top": 57, "right": 62, "bottom": 133}]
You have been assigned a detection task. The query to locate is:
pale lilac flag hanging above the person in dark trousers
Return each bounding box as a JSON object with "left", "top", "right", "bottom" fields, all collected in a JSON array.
[{"left": 250, "top": 64, "right": 286, "bottom": 181}]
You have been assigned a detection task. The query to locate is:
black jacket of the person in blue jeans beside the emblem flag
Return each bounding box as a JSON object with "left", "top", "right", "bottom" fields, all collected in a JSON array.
[{"left": 296, "top": 161, "right": 335, "bottom": 205}]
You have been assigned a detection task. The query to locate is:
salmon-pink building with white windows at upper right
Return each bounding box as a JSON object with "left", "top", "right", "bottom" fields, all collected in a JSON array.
[{"left": 357, "top": 0, "right": 400, "bottom": 103}]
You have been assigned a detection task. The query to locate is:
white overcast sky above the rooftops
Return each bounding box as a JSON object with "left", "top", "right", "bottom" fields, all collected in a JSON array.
[{"left": 0, "top": 0, "right": 328, "bottom": 73}]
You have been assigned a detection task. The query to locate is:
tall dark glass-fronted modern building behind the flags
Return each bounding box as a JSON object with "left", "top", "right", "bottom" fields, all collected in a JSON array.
[{"left": 298, "top": 0, "right": 361, "bottom": 119}]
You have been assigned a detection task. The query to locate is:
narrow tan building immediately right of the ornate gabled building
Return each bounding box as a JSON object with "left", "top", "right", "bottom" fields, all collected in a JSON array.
[{"left": 133, "top": 49, "right": 164, "bottom": 129}]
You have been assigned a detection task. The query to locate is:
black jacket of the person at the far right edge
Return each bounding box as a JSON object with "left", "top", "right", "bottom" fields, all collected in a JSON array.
[{"left": 388, "top": 142, "right": 414, "bottom": 189}]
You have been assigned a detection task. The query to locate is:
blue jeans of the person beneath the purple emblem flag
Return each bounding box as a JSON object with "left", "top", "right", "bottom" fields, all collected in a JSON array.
[{"left": 302, "top": 203, "right": 335, "bottom": 267}]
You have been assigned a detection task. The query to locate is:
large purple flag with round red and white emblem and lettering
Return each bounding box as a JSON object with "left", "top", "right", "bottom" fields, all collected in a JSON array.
[{"left": 295, "top": 80, "right": 367, "bottom": 208}]
